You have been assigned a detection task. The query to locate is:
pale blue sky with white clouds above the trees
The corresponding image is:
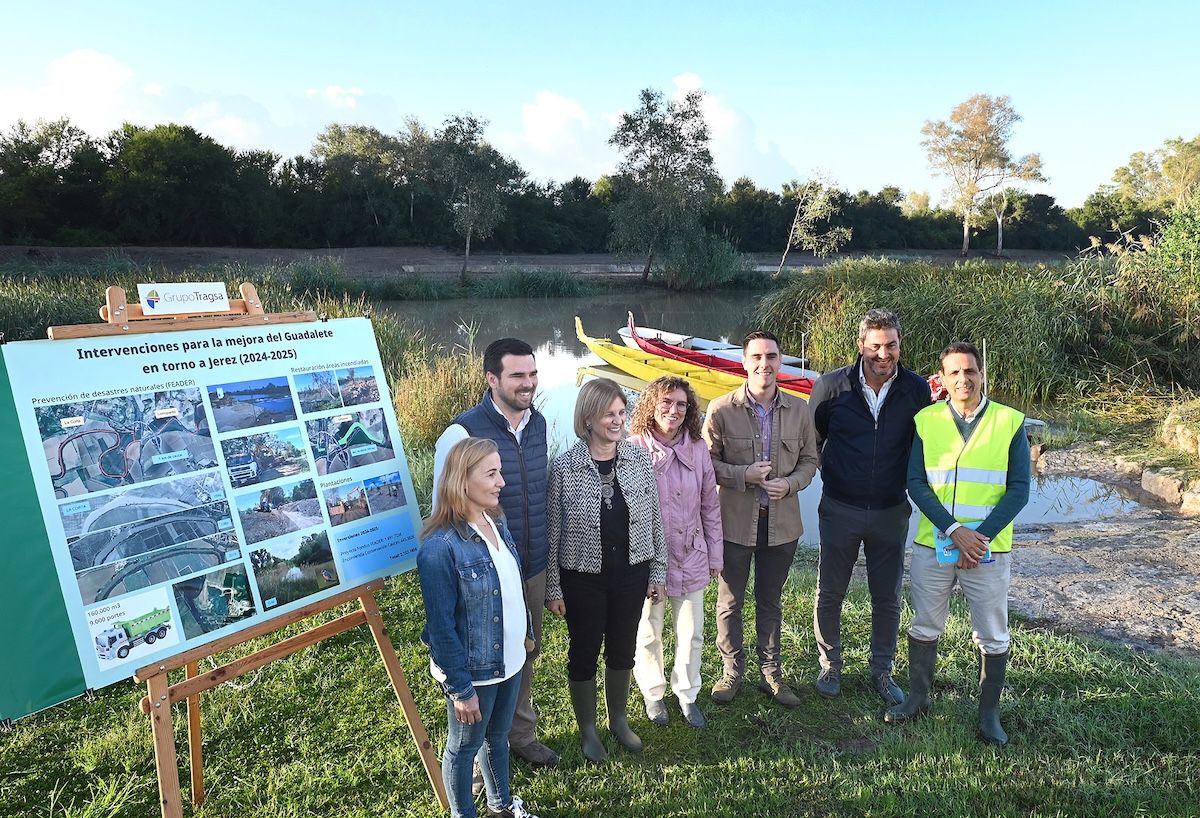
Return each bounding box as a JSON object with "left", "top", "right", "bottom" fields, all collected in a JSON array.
[{"left": 0, "top": 0, "right": 1200, "bottom": 206}]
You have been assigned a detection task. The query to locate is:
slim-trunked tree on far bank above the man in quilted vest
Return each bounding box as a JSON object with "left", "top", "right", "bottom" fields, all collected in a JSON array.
[{"left": 430, "top": 114, "right": 524, "bottom": 281}]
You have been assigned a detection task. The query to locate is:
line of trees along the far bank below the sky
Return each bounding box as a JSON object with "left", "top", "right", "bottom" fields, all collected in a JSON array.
[{"left": 0, "top": 97, "right": 1200, "bottom": 261}]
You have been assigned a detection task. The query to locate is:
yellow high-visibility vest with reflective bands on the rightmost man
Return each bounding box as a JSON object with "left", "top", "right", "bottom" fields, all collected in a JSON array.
[{"left": 914, "top": 401, "right": 1025, "bottom": 552}]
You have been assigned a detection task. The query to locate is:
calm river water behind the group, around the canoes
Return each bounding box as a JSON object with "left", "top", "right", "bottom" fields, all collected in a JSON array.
[{"left": 378, "top": 290, "right": 1138, "bottom": 542}]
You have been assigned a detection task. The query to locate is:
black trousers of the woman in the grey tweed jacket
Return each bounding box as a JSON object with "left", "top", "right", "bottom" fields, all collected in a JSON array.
[{"left": 559, "top": 554, "right": 650, "bottom": 681}]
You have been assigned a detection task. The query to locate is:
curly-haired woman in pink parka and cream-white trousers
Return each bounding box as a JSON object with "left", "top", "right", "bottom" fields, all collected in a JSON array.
[{"left": 629, "top": 375, "right": 724, "bottom": 728}]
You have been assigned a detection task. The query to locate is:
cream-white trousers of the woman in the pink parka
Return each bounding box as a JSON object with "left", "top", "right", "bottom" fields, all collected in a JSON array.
[{"left": 634, "top": 588, "right": 704, "bottom": 704}]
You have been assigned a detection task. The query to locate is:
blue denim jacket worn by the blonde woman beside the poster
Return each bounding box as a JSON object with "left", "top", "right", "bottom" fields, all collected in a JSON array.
[{"left": 416, "top": 519, "right": 533, "bottom": 700}]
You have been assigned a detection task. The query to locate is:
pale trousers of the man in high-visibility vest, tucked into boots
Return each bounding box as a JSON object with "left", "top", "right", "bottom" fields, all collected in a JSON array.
[{"left": 908, "top": 543, "right": 1013, "bottom": 655}]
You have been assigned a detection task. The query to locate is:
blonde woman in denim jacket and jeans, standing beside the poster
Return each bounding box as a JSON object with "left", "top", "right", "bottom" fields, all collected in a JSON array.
[{"left": 416, "top": 438, "right": 534, "bottom": 818}]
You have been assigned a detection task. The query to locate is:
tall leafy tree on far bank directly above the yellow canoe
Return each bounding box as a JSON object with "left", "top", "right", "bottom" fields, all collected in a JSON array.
[{"left": 608, "top": 89, "right": 721, "bottom": 281}]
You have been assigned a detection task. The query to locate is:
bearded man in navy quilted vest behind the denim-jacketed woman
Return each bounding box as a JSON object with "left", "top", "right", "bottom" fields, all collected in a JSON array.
[{"left": 433, "top": 338, "right": 558, "bottom": 768}]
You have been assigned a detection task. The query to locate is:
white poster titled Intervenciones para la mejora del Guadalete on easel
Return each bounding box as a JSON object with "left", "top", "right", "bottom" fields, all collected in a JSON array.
[{"left": 2, "top": 318, "right": 420, "bottom": 687}]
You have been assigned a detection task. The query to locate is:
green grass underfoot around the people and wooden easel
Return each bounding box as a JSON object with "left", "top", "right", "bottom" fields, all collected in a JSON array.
[{"left": 0, "top": 553, "right": 1200, "bottom": 818}]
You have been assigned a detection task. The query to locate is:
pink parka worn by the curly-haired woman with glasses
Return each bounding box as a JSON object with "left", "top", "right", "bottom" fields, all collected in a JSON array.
[{"left": 629, "top": 431, "right": 725, "bottom": 596}]
